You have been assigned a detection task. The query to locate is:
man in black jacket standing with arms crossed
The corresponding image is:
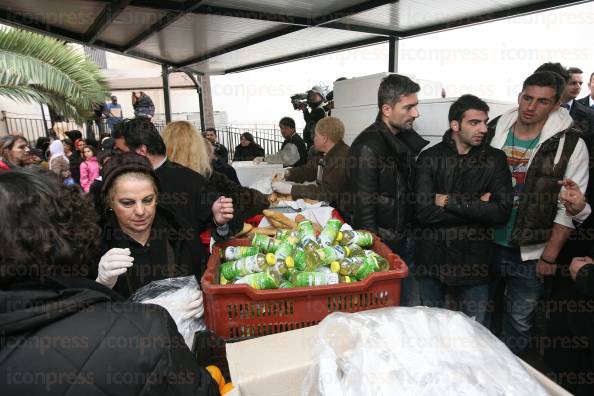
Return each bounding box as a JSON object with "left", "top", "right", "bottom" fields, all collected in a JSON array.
[{"left": 415, "top": 95, "right": 512, "bottom": 323}]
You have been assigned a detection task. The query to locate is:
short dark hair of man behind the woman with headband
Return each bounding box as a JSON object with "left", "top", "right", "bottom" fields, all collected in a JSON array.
[{"left": 113, "top": 117, "right": 166, "bottom": 155}]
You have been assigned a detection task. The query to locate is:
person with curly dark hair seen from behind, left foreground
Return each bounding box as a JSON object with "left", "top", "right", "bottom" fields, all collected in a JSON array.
[{"left": 0, "top": 170, "right": 218, "bottom": 396}]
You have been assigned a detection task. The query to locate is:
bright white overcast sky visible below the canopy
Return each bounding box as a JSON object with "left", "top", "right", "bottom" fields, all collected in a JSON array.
[{"left": 211, "top": 2, "right": 594, "bottom": 126}]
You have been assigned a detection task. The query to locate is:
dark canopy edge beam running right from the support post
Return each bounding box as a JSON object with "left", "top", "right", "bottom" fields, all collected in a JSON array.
[{"left": 400, "top": 0, "right": 588, "bottom": 38}]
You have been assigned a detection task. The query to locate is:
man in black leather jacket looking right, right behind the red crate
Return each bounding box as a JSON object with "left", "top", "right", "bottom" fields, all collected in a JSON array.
[{"left": 345, "top": 74, "right": 429, "bottom": 306}]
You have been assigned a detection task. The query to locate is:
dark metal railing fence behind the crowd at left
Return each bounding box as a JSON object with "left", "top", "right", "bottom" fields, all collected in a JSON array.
[{"left": 3, "top": 115, "right": 284, "bottom": 159}]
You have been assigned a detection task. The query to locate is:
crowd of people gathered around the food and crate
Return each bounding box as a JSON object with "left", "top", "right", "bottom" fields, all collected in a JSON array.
[{"left": 0, "top": 63, "right": 594, "bottom": 395}]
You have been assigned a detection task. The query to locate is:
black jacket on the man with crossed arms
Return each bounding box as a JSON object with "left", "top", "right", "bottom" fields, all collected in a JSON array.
[{"left": 415, "top": 131, "right": 513, "bottom": 286}]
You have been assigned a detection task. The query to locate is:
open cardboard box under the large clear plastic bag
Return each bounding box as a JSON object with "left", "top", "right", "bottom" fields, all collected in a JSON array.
[{"left": 227, "top": 326, "right": 571, "bottom": 396}]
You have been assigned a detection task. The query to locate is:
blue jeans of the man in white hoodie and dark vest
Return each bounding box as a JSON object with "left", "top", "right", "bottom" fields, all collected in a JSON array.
[{"left": 489, "top": 244, "right": 544, "bottom": 354}]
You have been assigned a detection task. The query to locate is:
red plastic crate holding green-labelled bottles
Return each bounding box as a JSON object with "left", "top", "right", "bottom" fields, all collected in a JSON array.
[{"left": 202, "top": 237, "right": 408, "bottom": 338}]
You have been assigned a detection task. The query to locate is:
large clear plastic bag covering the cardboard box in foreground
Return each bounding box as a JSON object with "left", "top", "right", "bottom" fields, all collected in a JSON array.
[{"left": 302, "top": 307, "right": 548, "bottom": 396}]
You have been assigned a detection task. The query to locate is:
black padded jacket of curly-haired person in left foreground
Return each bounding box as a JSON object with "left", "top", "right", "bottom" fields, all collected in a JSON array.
[{"left": 0, "top": 278, "right": 218, "bottom": 396}]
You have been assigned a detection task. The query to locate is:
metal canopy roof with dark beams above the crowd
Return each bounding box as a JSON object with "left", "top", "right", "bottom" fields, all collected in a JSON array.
[{"left": 0, "top": 0, "right": 587, "bottom": 74}]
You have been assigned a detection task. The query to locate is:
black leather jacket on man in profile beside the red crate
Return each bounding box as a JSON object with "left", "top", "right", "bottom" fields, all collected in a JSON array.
[{"left": 344, "top": 116, "right": 429, "bottom": 250}]
